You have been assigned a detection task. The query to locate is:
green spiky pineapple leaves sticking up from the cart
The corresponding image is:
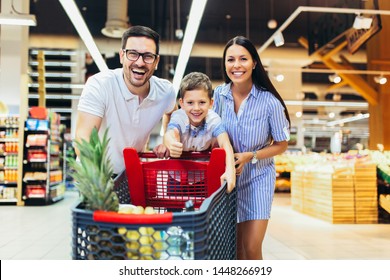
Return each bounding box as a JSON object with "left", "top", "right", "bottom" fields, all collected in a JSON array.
[{"left": 69, "top": 128, "right": 119, "bottom": 212}]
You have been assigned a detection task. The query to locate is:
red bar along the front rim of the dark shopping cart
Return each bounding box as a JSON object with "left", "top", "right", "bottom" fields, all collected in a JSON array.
[{"left": 93, "top": 210, "right": 173, "bottom": 225}]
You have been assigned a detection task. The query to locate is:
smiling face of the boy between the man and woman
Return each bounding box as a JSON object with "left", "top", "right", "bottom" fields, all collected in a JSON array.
[{"left": 179, "top": 89, "right": 213, "bottom": 126}]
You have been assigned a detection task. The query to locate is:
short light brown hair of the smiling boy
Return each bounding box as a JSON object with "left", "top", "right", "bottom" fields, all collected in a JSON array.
[{"left": 180, "top": 72, "right": 213, "bottom": 99}]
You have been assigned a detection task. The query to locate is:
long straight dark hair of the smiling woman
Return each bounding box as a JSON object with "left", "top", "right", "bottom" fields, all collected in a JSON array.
[{"left": 222, "top": 36, "right": 291, "bottom": 125}]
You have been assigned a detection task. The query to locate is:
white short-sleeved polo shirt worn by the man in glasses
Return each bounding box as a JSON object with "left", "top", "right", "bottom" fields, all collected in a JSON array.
[{"left": 78, "top": 68, "right": 176, "bottom": 174}]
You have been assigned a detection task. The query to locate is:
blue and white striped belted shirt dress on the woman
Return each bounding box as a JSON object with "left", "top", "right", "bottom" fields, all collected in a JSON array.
[{"left": 213, "top": 83, "right": 289, "bottom": 222}]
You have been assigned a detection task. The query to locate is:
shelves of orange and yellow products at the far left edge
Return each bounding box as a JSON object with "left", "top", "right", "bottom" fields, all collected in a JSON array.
[{"left": 0, "top": 115, "right": 19, "bottom": 204}]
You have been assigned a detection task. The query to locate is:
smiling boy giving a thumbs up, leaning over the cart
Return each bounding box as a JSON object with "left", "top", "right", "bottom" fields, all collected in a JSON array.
[{"left": 164, "top": 72, "right": 236, "bottom": 192}]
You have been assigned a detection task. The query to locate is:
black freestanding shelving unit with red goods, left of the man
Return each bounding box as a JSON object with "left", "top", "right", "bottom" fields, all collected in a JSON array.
[{"left": 22, "top": 113, "right": 65, "bottom": 204}]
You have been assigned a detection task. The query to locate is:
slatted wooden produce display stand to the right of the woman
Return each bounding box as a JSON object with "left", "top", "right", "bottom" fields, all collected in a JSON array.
[{"left": 291, "top": 162, "right": 378, "bottom": 224}]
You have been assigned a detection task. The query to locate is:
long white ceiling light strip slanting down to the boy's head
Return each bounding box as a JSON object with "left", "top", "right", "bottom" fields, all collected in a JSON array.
[{"left": 172, "top": 0, "right": 207, "bottom": 93}]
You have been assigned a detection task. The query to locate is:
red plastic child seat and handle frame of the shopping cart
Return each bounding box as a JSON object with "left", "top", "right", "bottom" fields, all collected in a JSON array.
[{"left": 123, "top": 147, "right": 225, "bottom": 209}]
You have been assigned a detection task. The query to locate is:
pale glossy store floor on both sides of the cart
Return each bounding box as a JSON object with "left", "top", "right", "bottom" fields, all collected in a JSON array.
[{"left": 0, "top": 191, "right": 390, "bottom": 260}]
